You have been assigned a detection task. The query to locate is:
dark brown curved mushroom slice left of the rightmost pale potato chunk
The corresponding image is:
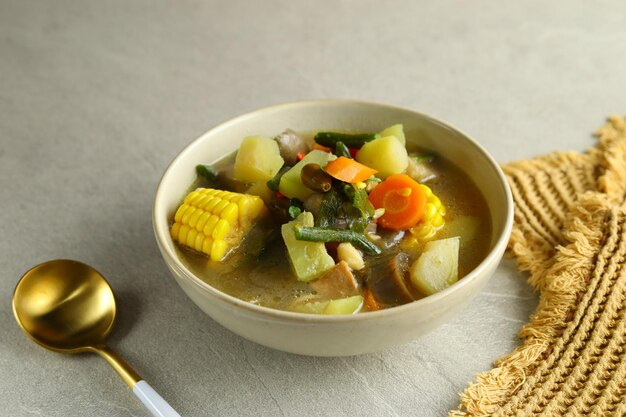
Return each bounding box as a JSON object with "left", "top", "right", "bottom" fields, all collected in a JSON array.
[{"left": 365, "top": 252, "right": 415, "bottom": 306}]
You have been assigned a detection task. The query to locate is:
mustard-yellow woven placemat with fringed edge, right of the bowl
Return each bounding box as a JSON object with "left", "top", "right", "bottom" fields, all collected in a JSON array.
[{"left": 450, "top": 116, "right": 626, "bottom": 416}]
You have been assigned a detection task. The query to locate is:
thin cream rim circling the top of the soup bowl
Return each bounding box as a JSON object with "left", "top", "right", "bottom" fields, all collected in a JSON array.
[{"left": 152, "top": 98, "right": 513, "bottom": 324}]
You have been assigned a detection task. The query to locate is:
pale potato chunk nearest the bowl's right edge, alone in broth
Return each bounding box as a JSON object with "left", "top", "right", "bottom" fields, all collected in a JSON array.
[{"left": 409, "top": 236, "right": 460, "bottom": 295}]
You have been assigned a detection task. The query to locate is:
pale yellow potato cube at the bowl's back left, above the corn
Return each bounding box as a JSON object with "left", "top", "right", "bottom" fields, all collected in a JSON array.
[{"left": 233, "top": 136, "right": 284, "bottom": 182}]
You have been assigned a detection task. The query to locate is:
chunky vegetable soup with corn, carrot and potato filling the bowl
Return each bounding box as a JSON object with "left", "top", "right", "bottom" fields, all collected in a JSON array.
[{"left": 170, "top": 125, "right": 491, "bottom": 314}]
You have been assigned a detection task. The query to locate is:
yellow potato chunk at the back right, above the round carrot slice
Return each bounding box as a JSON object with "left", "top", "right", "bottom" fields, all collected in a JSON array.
[{"left": 356, "top": 136, "right": 409, "bottom": 178}]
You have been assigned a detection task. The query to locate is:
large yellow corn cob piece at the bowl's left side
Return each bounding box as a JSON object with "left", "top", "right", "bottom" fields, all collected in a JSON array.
[{"left": 170, "top": 188, "right": 266, "bottom": 261}]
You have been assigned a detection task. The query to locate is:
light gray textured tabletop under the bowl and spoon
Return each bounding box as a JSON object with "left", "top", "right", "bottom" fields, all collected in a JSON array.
[{"left": 0, "top": 0, "right": 626, "bottom": 417}]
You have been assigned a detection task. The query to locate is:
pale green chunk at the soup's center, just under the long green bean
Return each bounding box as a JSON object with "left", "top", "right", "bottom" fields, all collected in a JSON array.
[{"left": 281, "top": 211, "right": 335, "bottom": 282}]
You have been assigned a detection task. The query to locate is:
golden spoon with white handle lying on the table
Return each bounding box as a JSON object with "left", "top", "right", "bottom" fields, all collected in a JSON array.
[{"left": 13, "top": 259, "right": 180, "bottom": 417}]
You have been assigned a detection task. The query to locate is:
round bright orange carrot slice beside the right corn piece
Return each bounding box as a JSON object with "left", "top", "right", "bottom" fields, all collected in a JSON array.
[{"left": 369, "top": 174, "right": 427, "bottom": 230}]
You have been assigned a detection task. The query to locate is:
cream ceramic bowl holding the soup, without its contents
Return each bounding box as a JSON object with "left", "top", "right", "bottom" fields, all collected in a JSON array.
[{"left": 152, "top": 100, "right": 513, "bottom": 356}]
